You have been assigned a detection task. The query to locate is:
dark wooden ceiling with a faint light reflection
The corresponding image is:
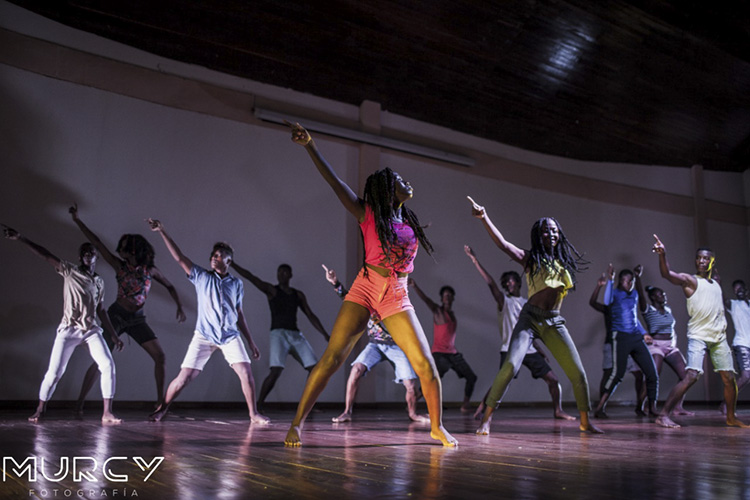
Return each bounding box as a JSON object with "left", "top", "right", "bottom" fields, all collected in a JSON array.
[{"left": 11, "top": 0, "right": 750, "bottom": 171}]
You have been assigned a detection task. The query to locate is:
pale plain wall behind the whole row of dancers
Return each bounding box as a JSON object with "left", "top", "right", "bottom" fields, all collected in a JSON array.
[{"left": 0, "top": 2, "right": 750, "bottom": 408}]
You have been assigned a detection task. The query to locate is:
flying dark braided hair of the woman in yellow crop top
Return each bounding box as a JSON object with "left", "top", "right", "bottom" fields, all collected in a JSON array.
[{"left": 526, "top": 217, "right": 588, "bottom": 284}]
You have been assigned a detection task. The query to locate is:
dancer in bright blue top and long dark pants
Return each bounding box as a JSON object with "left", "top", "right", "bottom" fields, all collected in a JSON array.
[{"left": 594, "top": 264, "right": 659, "bottom": 418}]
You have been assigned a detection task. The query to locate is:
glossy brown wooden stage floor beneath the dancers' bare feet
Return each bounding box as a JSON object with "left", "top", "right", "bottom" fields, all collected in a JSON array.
[{"left": 0, "top": 405, "right": 750, "bottom": 500}]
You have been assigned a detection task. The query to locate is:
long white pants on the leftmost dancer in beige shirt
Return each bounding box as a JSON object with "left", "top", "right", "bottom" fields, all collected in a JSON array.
[{"left": 39, "top": 325, "right": 115, "bottom": 401}]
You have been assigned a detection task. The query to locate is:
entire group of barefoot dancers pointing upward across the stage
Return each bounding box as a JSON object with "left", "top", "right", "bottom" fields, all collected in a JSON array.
[{"left": 3, "top": 123, "right": 750, "bottom": 446}]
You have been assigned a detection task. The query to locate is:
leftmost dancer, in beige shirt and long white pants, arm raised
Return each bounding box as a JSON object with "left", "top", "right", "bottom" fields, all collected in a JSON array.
[{"left": 3, "top": 225, "right": 123, "bottom": 424}]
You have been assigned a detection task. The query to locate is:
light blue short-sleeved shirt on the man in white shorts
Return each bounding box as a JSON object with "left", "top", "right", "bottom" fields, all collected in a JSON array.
[{"left": 188, "top": 264, "right": 245, "bottom": 344}]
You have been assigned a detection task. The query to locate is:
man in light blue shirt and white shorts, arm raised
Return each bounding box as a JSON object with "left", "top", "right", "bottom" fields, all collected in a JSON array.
[{"left": 148, "top": 219, "right": 270, "bottom": 424}]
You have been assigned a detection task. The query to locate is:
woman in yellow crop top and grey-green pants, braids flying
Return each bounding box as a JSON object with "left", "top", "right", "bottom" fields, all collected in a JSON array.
[{"left": 469, "top": 197, "right": 602, "bottom": 435}]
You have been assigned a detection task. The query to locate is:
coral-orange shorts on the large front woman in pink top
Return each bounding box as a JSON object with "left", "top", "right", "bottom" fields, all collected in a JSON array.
[{"left": 344, "top": 268, "right": 414, "bottom": 319}]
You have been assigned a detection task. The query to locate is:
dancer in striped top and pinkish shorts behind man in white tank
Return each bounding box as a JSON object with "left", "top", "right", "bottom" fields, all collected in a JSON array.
[{"left": 641, "top": 286, "right": 695, "bottom": 415}]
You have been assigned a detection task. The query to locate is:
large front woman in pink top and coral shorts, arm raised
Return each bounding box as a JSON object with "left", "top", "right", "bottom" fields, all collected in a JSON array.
[{"left": 284, "top": 123, "right": 458, "bottom": 446}]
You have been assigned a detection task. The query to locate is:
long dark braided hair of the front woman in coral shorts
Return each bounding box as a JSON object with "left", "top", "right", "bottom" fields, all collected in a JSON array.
[{"left": 364, "top": 167, "right": 433, "bottom": 272}]
